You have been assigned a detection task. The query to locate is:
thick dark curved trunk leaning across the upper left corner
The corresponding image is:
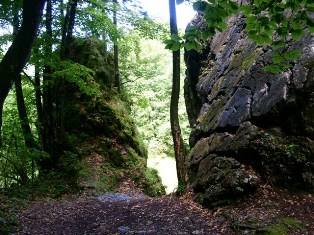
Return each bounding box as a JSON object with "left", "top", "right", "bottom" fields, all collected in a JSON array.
[{"left": 0, "top": 0, "right": 46, "bottom": 146}]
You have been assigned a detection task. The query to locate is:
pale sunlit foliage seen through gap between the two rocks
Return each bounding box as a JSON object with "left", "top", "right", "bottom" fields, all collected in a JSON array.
[{"left": 124, "top": 36, "right": 190, "bottom": 160}]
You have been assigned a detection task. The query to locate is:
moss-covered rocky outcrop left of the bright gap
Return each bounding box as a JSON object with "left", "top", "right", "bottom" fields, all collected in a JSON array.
[{"left": 62, "top": 39, "right": 165, "bottom": 196}]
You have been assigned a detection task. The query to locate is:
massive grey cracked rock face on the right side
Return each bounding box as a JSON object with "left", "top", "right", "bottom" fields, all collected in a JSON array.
[{"left": 185, "top": 16, "right": 314, "bottom": 207}]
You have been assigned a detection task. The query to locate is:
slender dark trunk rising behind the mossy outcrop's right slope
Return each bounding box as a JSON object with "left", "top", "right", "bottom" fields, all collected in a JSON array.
[{"left": 113, "top": 0, "right": 121, "bottom": 90}]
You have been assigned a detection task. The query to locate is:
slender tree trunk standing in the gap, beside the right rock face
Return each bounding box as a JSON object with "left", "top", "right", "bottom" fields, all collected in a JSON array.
[{"left": 169, "top": 0, "right": 188, "bottom": 190}]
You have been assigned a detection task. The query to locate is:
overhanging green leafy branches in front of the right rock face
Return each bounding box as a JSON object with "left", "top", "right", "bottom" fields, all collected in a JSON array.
[{"left": 165, "top": 0, "right": 314, "bottom": 73}]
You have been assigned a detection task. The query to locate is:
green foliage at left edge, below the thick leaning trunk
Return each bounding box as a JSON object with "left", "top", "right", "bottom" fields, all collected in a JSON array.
[{"left": 0, "top": 79, "right": 40, "bottom": 188}]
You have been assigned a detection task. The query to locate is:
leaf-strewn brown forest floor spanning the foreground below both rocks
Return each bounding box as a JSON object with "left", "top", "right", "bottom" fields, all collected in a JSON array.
[{"left": 9, "top": 181, "right": 314, "bottom": 235}]
